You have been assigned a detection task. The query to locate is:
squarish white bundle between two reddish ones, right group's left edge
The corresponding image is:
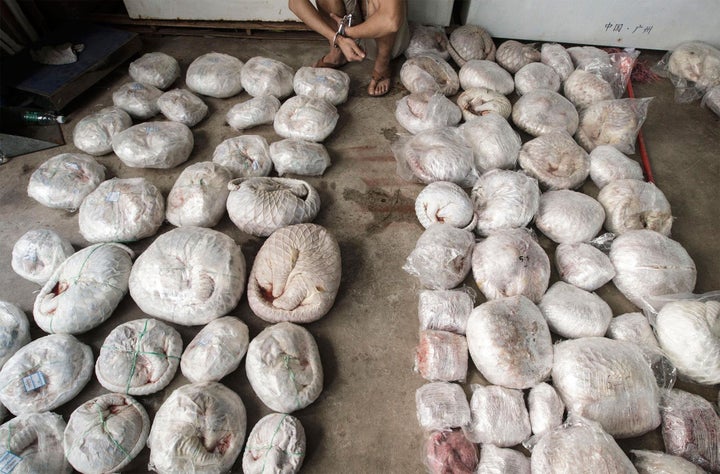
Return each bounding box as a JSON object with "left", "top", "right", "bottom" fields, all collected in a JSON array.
[{"left": 415, "top": 382, "right": 470, "bottom": 431}]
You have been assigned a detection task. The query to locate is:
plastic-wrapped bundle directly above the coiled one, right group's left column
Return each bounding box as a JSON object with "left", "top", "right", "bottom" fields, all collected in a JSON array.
[{"left": 392, "top": 127, "right": 478, "bottom": 187}]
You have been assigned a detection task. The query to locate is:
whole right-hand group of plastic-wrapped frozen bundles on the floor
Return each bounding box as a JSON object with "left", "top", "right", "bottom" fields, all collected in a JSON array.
[{"left": 402, "top": 25, "right": 720, "bottom": 474}]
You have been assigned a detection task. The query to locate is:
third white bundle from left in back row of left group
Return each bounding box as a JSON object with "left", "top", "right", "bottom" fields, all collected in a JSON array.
[{"left": 240, "top": 56, "right": 295, "bottom": 99}]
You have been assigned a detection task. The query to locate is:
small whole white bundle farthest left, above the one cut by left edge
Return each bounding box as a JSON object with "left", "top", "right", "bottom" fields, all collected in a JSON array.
[{"left": 11, "top": 229, "right": 75, "bottom": 286}]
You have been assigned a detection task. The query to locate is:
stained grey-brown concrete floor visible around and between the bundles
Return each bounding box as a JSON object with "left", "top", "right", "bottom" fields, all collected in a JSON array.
[{"left": 0, "top": 31, "right": 720, "bottom": 473}]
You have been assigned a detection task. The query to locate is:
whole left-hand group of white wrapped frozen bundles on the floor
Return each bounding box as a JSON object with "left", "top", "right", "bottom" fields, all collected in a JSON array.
[{"left": 0, "top": 53, "right": 349, "bottom": 473}]
